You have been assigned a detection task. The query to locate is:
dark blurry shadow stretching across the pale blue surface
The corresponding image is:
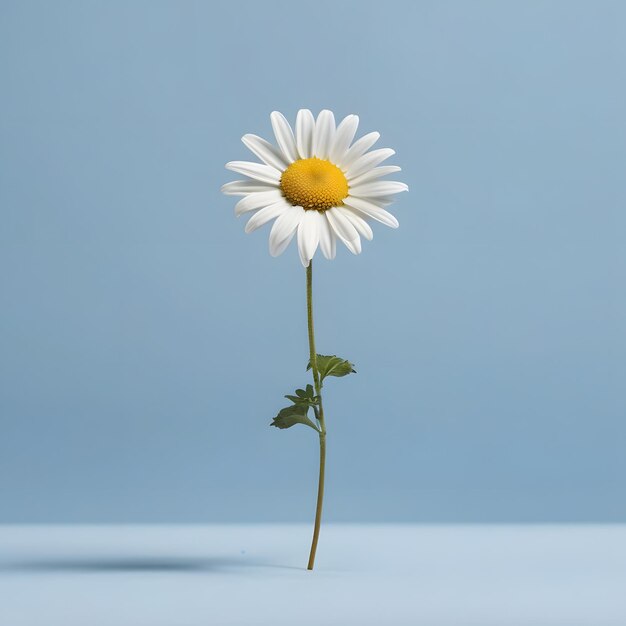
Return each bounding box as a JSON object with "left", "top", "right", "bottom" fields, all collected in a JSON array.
[{"left": 0, "top": 556, "right": 303, "bottom": 573}]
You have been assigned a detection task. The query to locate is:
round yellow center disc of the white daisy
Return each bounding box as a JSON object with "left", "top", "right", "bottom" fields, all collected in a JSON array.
[{"left": 280, "top": 157, "right": 348, "bottom": 211}]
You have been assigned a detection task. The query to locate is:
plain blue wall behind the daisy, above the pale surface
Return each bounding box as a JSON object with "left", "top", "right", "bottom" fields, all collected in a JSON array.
[{"left": 0, "top": 1, "right": 626, "bottom": 522}]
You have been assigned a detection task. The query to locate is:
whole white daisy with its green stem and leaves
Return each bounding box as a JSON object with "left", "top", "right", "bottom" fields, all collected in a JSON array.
[{"left": 222, "top": 109, "right": 408, "bottom": 570}]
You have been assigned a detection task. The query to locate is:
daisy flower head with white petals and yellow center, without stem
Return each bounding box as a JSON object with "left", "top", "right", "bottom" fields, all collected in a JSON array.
[{"left": 222, "top": 109, "right": 408, "bottom": 267}]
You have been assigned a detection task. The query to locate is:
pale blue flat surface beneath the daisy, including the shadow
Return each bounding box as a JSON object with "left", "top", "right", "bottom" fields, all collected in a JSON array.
[{"left": 0, "top": 524, "right": 626, "bottom": 626}]
